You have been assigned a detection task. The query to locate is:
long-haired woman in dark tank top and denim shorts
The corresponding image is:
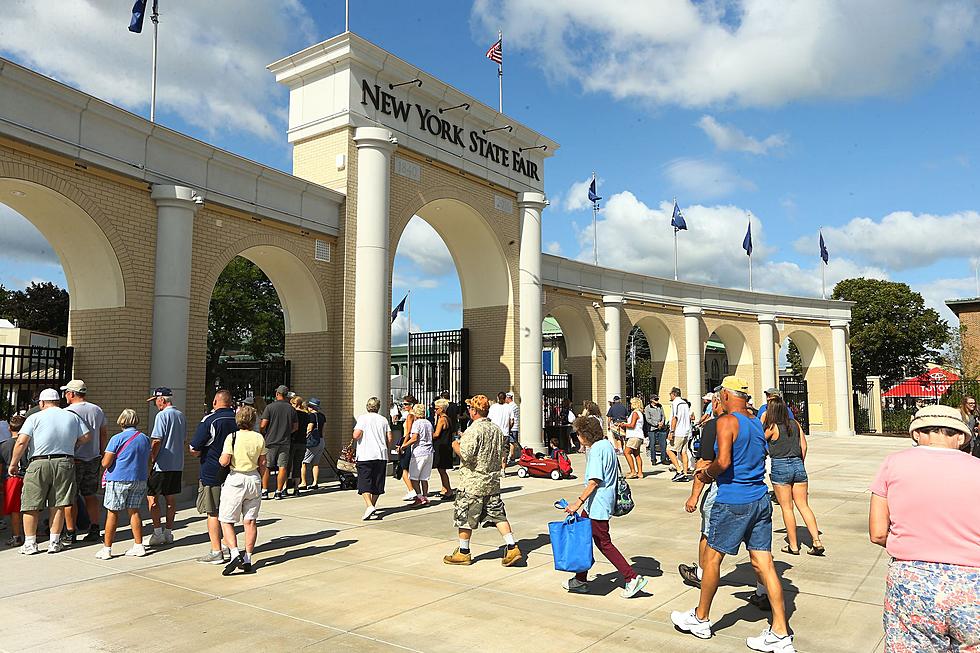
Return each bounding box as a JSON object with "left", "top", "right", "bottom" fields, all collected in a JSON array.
[{"left": 762, "top": 396, "right": 826, "bottom": 556}]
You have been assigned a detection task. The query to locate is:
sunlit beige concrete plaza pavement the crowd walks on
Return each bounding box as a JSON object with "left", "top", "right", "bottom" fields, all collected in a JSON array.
[{"left": 0, "top": 436, "right": 908, "bottom": 653}]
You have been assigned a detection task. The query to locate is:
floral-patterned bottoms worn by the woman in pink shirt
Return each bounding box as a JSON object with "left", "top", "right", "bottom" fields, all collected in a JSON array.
[{"left": 884, "top": 560, "right": 980, "bottom": 653}]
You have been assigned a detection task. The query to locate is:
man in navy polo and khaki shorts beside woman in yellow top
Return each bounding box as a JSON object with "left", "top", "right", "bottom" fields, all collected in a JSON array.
[{"left": 190, "top": 390, "right": 238, "bottom": 565}]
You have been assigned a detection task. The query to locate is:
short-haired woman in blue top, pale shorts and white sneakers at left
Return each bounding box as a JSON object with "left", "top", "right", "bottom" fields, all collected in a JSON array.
[{"left": 95, "top": 408, "right": 150, "bottom": 560}]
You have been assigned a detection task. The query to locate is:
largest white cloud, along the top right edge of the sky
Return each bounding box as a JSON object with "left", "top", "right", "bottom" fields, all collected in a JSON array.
[{"left": 472, "top": 0, "right": 980, "bottom": 107}]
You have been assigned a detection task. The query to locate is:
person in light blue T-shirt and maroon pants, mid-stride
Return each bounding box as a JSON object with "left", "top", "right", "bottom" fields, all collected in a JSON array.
[{"left": 562, "top": 416, "right": 647, "bottom": 599}]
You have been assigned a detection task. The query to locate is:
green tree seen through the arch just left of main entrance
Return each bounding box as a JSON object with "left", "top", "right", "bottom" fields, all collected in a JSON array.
[{"left": 207, "top": 256, "right": 286, "bottom": 388}]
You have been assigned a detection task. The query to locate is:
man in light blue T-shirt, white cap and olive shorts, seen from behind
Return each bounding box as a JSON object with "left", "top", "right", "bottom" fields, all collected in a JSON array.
[{"left": 7, "top": 388, "right": 92, "bottom": 555}]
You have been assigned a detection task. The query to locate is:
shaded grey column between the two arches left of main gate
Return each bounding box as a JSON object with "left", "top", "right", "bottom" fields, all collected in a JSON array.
[{"left": 150, "top": 184, "right": 199, "bottom": 410}]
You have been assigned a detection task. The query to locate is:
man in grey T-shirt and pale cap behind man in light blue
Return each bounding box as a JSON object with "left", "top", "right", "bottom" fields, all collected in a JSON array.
[{"left": 61, "top": 379, "right": 109, "bottom": 544}]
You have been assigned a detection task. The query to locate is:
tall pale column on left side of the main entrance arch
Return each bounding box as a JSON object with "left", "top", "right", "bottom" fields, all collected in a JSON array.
[{"left": 353, "top": 127, "right": 396, "bottom": 414}]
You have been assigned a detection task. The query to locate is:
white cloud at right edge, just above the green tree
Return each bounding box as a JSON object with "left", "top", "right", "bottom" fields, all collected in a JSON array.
[{"left": 794, "top": 211, "right": 980, "bottom": 270}]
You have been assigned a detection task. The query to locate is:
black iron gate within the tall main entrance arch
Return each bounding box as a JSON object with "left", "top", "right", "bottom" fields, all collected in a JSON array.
[{"left": 408, "top": 329, "right": 470, "bottom": 406}]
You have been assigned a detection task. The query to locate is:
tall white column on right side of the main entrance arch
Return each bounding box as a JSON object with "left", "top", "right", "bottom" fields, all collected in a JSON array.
[{"left": 517, "top": 192, "right": 548, "bottom": 451}]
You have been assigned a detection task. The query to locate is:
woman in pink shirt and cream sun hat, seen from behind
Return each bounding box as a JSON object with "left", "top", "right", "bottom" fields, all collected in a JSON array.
[{"left": 868, "top": 406, "right": 980, "bottom": 653}]
